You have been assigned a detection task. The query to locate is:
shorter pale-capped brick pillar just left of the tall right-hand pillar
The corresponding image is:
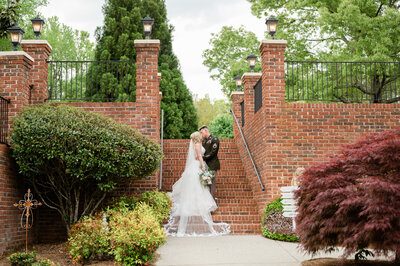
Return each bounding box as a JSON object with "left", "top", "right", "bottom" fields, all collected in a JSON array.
[{"left": 242, "top": 72, "right": 262, "bottom": 126}]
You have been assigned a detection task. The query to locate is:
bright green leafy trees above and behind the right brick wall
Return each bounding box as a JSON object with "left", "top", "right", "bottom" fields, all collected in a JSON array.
[{"left": 203, "top": 0, "right": 400, "bottom": 103}]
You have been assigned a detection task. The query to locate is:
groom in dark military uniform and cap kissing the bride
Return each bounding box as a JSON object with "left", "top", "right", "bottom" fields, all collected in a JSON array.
[{"left": 199, "top": 126, "right": 220, "bottom": 197}]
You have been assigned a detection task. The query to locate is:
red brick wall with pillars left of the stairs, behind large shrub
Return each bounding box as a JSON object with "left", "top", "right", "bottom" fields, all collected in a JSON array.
[{"left": 0, "top": 40, "right": 161, "bottom": 244}]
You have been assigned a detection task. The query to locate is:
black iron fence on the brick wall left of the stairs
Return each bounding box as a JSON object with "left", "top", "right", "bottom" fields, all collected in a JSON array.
[{"left": 48, "top": 61, "right": 136, "bottom": 102}]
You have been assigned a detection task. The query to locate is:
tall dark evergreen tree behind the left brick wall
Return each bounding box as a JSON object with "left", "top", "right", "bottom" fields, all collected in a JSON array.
[{"left": 92, "top": 0, "right": 198, "bottom": 139}]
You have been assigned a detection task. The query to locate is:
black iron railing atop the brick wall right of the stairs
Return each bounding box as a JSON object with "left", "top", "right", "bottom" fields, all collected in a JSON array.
[{"left": 285, "top": 61, "right": 400, "bottom": 103}]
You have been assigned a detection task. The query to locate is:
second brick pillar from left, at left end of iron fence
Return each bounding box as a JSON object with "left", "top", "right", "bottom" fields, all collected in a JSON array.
[{"left": 21, "top": 40, "right": 52, "bottom": 104}]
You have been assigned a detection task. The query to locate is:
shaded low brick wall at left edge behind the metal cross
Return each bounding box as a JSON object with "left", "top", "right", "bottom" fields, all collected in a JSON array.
[{"left": 0, "top": 144, "right": 37, "bottom": 256}]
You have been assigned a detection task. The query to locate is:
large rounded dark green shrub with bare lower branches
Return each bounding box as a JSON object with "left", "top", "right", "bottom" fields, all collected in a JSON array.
[{"left": 10, "top": 104, "right": 162, "bottom": 231}]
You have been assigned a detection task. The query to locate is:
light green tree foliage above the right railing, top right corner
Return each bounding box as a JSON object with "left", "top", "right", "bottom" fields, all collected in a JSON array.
[{"left": 248, "top": 0, "right": 400, "bottom": 61}]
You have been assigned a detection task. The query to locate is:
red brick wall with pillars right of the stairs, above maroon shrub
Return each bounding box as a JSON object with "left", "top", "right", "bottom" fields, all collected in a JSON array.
[{"left": 232, "top": 40, "right": 400, "bottom": 211}]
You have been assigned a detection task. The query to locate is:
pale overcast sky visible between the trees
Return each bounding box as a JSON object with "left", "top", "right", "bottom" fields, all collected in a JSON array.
[{"left": 40, "top": 0, "right": 266, "bottom": 100}]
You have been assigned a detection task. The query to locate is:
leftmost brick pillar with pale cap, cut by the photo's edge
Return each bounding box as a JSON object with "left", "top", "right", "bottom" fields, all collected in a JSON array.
[{"left": 0, "top": 51, "right": 34, "bottom": 128}]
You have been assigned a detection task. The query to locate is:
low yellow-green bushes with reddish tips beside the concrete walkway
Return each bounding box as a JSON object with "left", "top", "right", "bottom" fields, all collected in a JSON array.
[{"left": 68, "top": 191, "right": 172, "bottom": 265}]
